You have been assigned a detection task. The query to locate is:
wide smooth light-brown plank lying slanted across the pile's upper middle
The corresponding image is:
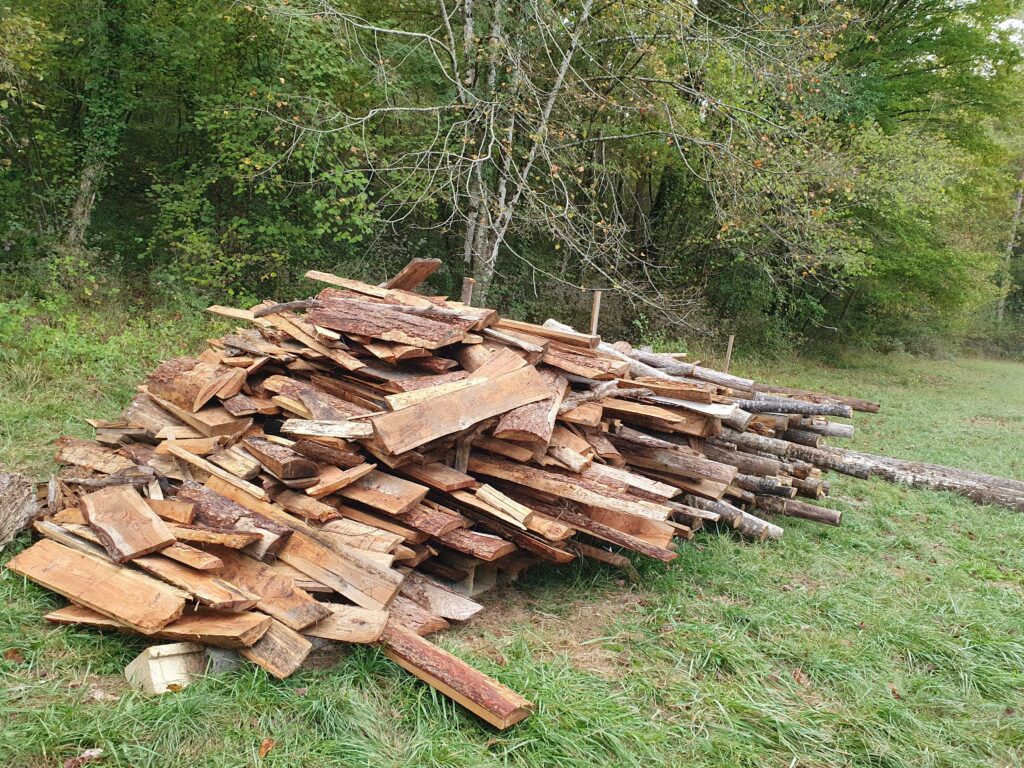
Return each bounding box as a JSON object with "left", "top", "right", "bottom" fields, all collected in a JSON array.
[{"left": 370, "top": 367, "right": 550, "bottom": 454}]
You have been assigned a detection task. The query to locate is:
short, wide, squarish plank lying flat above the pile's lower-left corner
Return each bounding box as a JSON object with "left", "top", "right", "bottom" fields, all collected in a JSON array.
[{"left": 82, "top": 485, "right": 174, "bottom": 562}]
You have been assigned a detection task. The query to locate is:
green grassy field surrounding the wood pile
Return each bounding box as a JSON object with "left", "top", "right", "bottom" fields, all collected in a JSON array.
[{"left": 0, "top": 307, "right": 1024, "bottom": 768}]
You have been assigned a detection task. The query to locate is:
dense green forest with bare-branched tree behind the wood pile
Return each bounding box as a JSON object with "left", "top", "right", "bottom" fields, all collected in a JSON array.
[{"left": 0, "top": 0, "right": 1024, "bottom": 358}]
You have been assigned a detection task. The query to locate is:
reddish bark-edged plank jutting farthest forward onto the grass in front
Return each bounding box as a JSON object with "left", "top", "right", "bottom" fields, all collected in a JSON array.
[{"left": 382, "top": 622, "right": 534, "bottom": 728}]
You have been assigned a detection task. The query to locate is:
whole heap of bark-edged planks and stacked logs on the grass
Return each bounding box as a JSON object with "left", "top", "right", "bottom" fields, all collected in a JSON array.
[{"left": 7, "top": 260, "right": 878, "bottom": 727}]
